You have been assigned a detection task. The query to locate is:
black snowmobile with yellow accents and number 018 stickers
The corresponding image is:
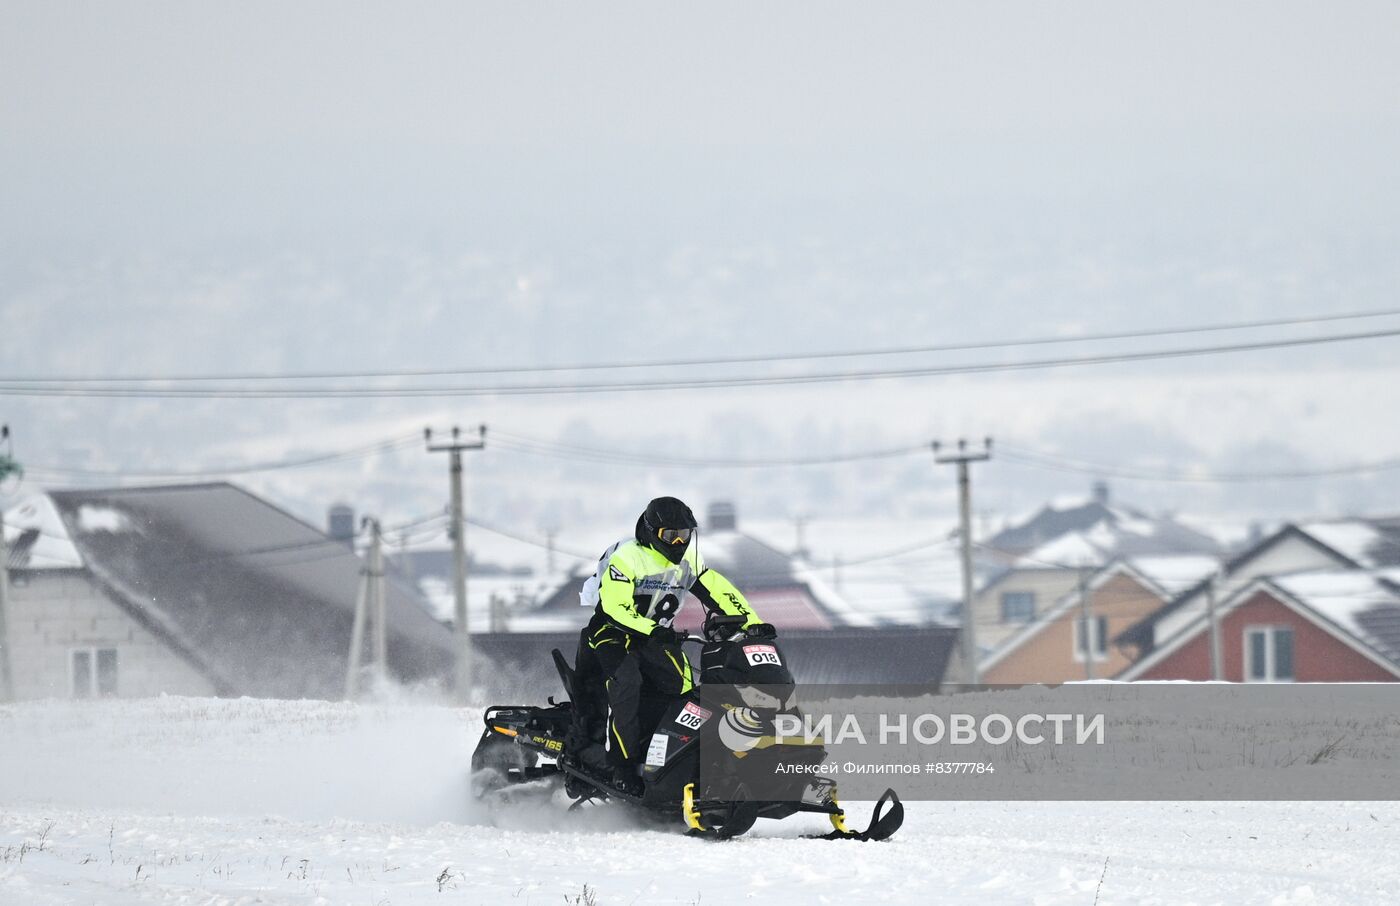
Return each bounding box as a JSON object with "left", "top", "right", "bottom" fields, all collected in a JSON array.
[{"left": 472, "top": 615, "right": 904, "bottom": 840}]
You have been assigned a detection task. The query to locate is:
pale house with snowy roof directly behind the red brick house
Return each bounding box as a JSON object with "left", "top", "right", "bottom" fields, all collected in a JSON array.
[{"left": 1114, "top": 518, "right": 1400, "bottom": 655}]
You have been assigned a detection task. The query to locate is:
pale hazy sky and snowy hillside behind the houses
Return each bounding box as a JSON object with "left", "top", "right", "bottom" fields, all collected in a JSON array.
[{"left": 0, "top": 0, "right": 1400, "bottom": 539}]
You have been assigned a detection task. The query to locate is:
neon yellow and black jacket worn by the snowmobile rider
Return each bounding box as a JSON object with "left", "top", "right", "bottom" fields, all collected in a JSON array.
[{"left": 578, "top": 538, "right": 763, "bottom": 636}]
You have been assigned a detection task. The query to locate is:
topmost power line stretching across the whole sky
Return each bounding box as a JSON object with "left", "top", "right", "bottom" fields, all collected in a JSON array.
[{"left": 10, "top": 308, "right": 1400, "bottom": 384}]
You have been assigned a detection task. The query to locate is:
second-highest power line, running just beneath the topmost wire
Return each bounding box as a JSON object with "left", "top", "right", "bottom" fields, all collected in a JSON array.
[{"left": 0, "top": 328, "right": 1400, "bottom": 399}]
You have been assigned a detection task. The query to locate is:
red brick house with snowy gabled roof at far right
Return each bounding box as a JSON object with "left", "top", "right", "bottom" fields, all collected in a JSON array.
[{"left": 1120, "top": 570, "right": 1400, "bottom": 682}]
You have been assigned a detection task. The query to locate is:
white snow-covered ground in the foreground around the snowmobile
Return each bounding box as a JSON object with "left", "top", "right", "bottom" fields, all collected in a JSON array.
[{"left": 0, "top": 699, "right": 1400, "bottom": 906}]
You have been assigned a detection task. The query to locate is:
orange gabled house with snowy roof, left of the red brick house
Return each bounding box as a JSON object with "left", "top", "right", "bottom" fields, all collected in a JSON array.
[{"left": 979, "top": 555, "right": 1218, "bottom": 683}]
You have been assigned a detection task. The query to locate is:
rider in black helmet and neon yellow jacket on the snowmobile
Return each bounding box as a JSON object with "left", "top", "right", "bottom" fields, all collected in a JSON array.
[{"left": 575, "top": 497, "right": 777, "bottom": 795}]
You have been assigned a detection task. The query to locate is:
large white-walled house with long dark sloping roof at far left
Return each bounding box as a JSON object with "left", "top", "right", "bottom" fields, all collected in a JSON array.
[{"left": 3, "top": 482, "right": 452, "bottom": 699}]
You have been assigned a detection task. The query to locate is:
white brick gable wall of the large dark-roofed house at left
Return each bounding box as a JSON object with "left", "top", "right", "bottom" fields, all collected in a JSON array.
[{"left": 6, "top": 570, "right": 216, "bottom": 699}]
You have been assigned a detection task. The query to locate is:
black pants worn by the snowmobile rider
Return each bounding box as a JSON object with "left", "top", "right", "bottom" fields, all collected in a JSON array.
[{"left": 574, "top": 615, "right": 694, "bottom": 766}]
